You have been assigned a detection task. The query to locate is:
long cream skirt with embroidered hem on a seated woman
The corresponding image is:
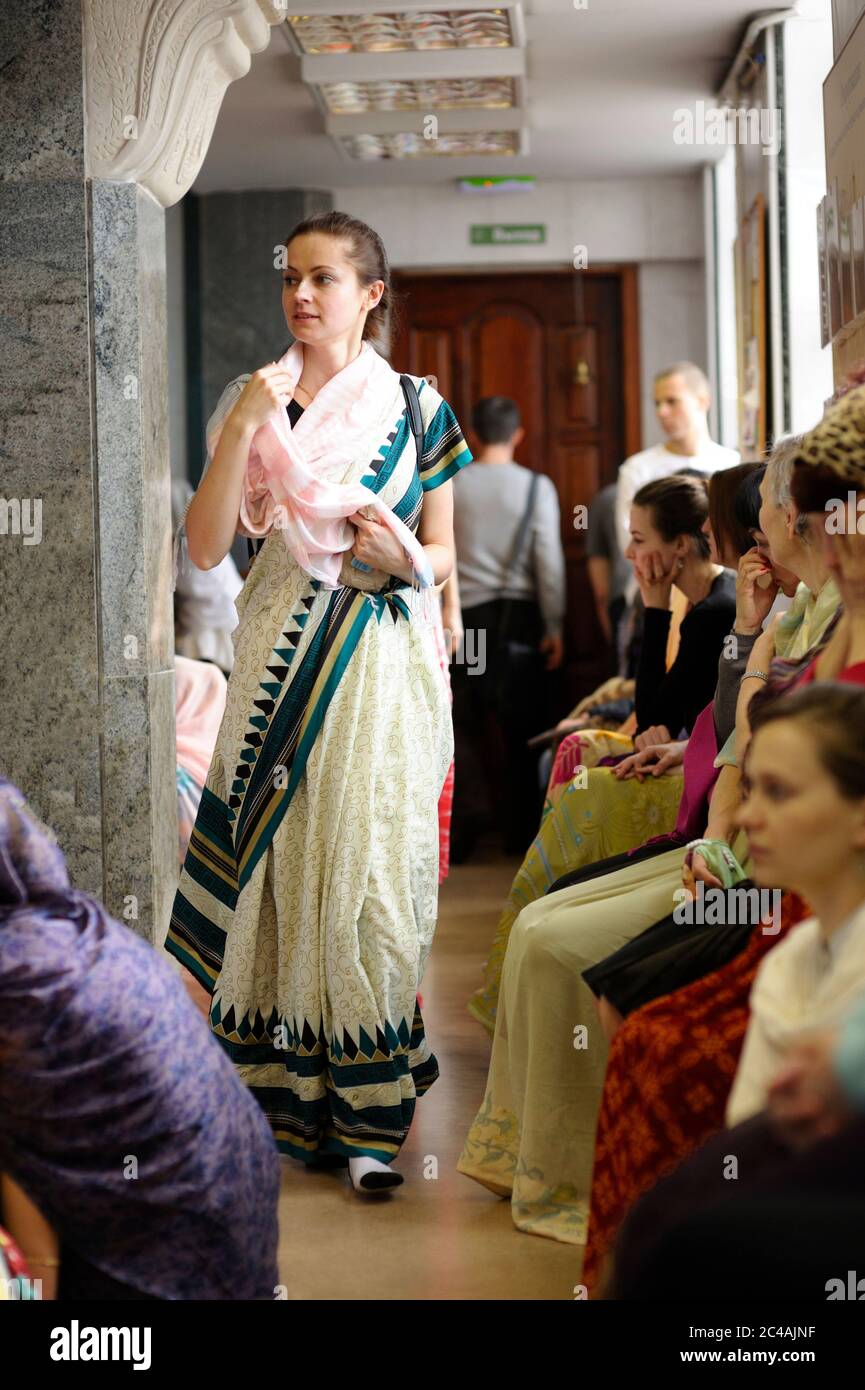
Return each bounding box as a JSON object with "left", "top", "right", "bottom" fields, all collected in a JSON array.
[{"left": 458, "top": 430, "right": 845, "bottom": 1244}]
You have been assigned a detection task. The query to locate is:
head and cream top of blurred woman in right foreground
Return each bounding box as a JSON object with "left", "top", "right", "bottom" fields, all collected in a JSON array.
[{"left": 727, "top": 683, "right": 865, "bottom": 1125}]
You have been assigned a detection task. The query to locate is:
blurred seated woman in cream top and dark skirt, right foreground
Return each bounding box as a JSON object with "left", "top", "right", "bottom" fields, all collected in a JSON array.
[{"left": 613, "top": 682, "right": 865, "bottom": 1298}]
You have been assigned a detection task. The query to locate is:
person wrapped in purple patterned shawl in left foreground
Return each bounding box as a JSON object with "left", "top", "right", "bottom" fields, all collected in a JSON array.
[{"left": 0, "top": 778, "right": 280, "bottom": 1300}]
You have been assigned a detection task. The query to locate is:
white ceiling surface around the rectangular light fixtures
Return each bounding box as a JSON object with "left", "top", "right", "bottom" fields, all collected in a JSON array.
[{"left": 193, "top": 0, "right": 789, "bottom": 193}]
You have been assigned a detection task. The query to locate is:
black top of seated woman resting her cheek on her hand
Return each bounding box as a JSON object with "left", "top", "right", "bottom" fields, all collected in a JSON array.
[{"left": 636, "top": 574, "right": 736, "bottom": 738}]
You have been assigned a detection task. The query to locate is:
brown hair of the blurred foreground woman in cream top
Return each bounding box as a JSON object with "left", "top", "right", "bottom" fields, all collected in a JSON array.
[{"left": 748, "top": 681, "right": 865, "bottom": 801}]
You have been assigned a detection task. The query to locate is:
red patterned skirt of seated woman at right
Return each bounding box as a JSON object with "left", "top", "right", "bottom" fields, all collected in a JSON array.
[{"left": 583, "top": 894, "right": 808, "bottom": 1291}]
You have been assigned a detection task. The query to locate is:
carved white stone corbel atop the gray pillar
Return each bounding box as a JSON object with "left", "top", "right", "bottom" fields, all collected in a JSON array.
[{"left": 83, "top": 0, "right": 288, "bottom": 207}]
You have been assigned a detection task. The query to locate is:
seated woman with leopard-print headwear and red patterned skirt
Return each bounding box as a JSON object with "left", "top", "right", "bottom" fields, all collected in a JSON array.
[{"left": 584, "top": 386, "right": 865, "bottom": 1286}]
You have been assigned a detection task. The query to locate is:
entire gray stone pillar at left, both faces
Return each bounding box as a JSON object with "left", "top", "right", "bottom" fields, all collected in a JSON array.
[{"left": 0, "top": 0, "right": 177, "bottom": 935}]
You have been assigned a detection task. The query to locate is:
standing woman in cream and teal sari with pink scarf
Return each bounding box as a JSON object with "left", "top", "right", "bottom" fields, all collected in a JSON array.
[{"left": 167, "top": 213, "right": 471, "bottom": 1190}]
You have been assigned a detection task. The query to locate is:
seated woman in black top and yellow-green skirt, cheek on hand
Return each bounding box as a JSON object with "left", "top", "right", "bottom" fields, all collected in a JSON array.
[{"left": 469, "top": 470, "right": 751, "bottom": 1033}]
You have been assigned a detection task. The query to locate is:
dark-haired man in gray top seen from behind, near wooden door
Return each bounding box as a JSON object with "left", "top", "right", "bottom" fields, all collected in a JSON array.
[{"left": 451, "top": 396, "right": 565, "bottom": 863}]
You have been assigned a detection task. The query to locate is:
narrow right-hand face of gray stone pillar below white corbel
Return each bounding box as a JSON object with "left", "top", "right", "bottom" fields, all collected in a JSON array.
[{"left": 90, "top": 179, "right": 178, "bottom": 938}]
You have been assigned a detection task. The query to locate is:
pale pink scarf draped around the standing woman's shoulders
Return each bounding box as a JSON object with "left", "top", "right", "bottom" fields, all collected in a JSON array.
[{"left": 209, "top": 342, "right": 434, "bottom": 589}]
